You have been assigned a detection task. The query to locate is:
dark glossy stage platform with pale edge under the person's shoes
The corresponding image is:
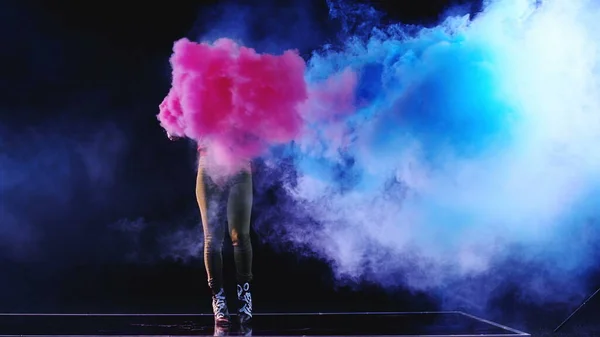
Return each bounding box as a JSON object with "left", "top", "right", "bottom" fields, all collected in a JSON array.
[{"left": 0, "top": 311, "right": 529, "bottom": 336}]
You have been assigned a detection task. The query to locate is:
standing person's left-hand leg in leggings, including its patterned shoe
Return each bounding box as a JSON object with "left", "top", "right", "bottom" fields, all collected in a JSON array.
[{"left": 196, "top": 156, "right": 229, "bottom": 323}]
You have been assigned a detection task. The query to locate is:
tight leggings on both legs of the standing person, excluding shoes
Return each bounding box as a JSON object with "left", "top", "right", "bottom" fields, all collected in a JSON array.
[{"left": 196, "top": 156, "right": 252, "bottom": 293}]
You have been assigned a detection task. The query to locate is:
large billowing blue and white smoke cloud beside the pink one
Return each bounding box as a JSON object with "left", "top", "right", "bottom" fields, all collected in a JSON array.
[{"left": 256, "top": 0, "right": 600, "bottom": 307}]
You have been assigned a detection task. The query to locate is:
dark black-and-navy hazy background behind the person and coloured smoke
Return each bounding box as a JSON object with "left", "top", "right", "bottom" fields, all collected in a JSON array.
[{"left": 0, "top": 0, "right": 600, "bottom": 330}]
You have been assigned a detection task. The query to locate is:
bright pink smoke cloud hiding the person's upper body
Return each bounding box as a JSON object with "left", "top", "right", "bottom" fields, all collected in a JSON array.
[{"left": 157, "top": 39, "right": 357, "bottom": 171}]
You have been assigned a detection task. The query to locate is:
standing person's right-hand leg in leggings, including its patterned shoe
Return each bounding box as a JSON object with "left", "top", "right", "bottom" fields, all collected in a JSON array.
[{"left": 227, "top": 167, "right": 253, "bottom": 323}]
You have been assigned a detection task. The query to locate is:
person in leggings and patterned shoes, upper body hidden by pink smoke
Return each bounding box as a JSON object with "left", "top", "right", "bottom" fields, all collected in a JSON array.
[{"left": 169, "top": 135, "right": 252, "bottom": 325}]
